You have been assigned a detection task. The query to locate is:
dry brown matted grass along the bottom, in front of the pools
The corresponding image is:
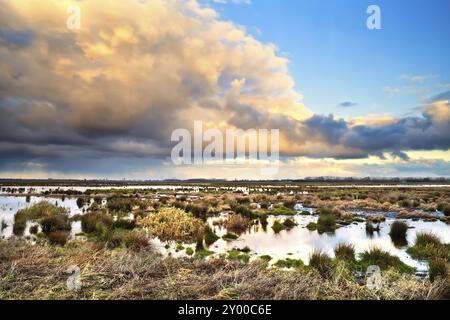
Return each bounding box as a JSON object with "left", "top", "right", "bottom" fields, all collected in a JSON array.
[{"left": 0, "top": 240, "right": 449, "bottom": 300}]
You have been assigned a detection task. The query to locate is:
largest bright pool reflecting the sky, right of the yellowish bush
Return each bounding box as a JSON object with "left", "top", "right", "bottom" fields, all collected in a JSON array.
[{"left": 208, "top": 212, "right": 450, "bottom": 272}]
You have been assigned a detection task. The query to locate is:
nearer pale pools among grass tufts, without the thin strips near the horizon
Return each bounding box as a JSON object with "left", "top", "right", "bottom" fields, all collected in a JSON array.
[{"left": 0, "top": 196, "right": 450, "bottom": 273}]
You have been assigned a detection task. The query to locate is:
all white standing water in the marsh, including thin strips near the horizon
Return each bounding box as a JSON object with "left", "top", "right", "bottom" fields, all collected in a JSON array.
[{"left": 0, "top": 186, "right": 450, "bottom": 273}]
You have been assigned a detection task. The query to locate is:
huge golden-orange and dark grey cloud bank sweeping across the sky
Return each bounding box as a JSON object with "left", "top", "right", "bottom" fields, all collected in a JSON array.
[{"left": 0, "top": 0, "right": 450, "bottom": 176}]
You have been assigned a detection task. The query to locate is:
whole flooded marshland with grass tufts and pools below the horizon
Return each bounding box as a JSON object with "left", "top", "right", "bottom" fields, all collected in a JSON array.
[{"left": 0, "top": 184, "right": 450, "bottom": 299}]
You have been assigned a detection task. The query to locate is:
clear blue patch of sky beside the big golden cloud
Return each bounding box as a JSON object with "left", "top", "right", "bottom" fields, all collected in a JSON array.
[{"left": 210, "top": 0, "right": 450, "bottom": 116}]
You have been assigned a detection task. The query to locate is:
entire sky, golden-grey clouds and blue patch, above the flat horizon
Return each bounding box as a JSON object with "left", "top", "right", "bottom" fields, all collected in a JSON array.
[{"left": 0, "top": 0, "right": 450, "bottom": 179}]
